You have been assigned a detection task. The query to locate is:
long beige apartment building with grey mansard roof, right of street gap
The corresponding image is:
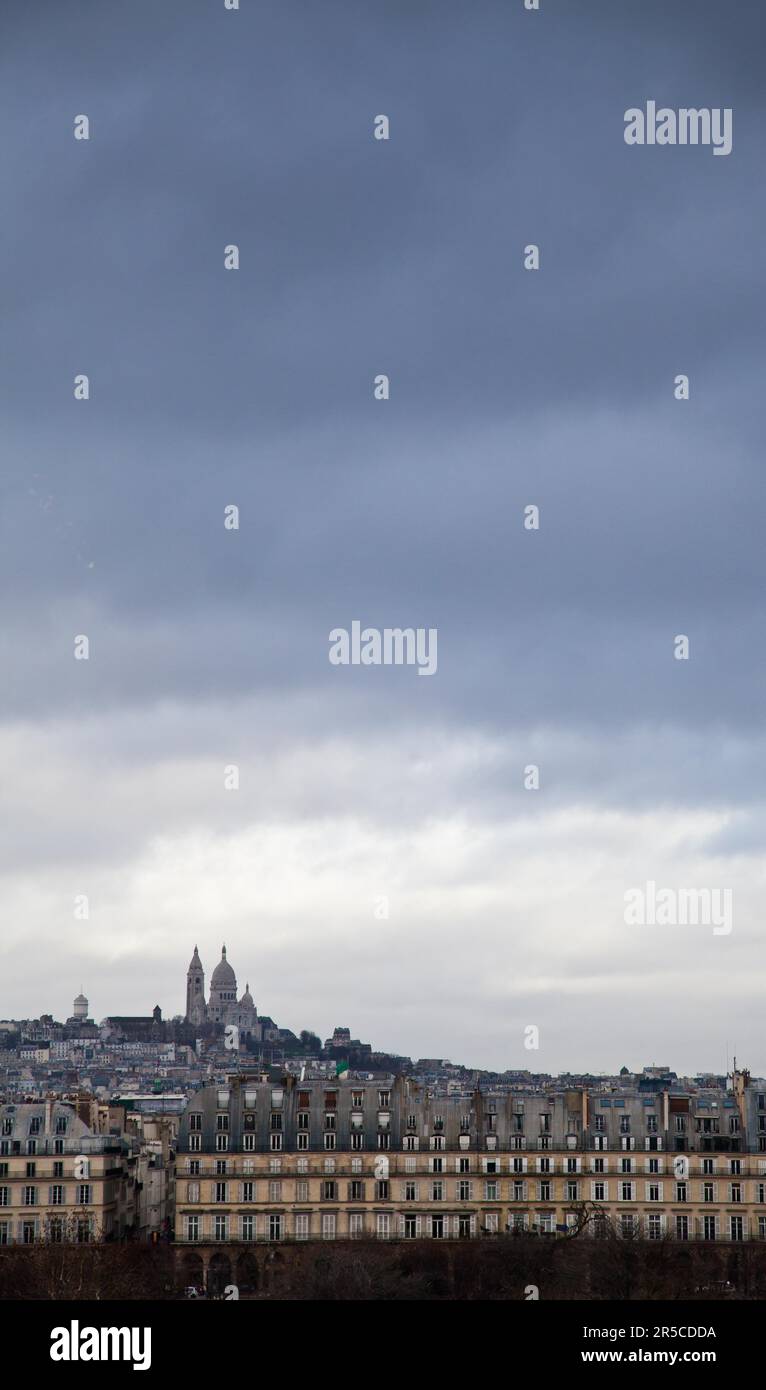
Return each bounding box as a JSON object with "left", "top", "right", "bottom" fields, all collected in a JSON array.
[{"left": 175, "top": 1072, "right": 766, "bottom": 1245}]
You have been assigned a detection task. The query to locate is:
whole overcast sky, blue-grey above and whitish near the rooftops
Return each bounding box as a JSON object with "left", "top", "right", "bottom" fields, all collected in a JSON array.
[{"left": 0, "top": 0, "right": 766, "bottom": 1074}]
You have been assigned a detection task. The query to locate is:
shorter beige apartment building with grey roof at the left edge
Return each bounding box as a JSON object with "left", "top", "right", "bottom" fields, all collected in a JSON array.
[{"left": 0, "top": 1101, "right": 135, "bottom": 1245}]
